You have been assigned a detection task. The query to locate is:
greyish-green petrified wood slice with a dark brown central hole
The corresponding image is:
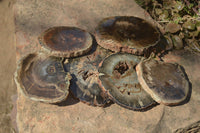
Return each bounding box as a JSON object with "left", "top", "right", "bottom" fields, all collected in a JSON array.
[{"left": 99, "top": 54, "right": 155, "bottom": 110}]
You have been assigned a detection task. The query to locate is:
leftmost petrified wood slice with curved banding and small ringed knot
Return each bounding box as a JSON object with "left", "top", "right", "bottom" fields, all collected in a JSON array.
[{"left": 15, "top": 53, "right": 71, "bottom": 103}]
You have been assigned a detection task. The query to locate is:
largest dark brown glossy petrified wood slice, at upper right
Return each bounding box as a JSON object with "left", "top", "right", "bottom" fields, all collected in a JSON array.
[{"left": 95, "top": 16, "right": 160, "bottom": 55}]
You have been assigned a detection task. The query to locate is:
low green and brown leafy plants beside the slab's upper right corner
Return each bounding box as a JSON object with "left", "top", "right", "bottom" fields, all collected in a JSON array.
[{"left": 137, "top": 0, "right": 200, "bottom": 52}]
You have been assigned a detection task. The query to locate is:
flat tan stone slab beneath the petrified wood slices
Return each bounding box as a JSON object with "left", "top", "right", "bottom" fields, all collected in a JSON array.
[{"left": 14, "top": 0, "right": 200, "bottom": 133}]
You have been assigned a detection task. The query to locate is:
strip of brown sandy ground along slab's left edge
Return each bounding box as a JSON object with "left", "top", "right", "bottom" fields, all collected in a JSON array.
[{"left": 0, "top": 0, "right": 16, "bottom": 133}]
